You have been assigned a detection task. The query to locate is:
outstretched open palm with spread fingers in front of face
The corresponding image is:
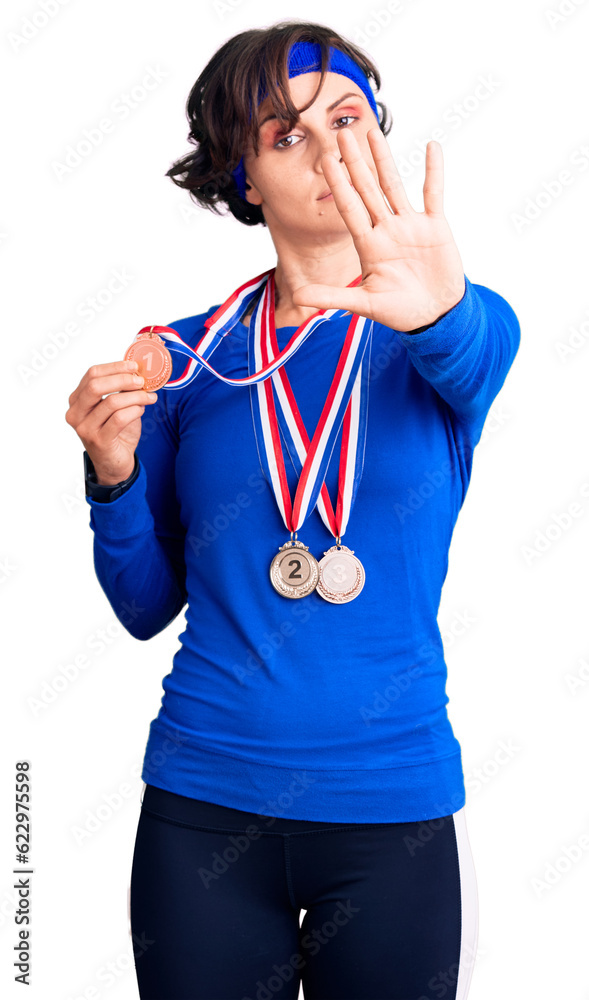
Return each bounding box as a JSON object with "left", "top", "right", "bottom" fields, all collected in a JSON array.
[{"left": 293, "top": 127, "right": 465, "bottom": 332}]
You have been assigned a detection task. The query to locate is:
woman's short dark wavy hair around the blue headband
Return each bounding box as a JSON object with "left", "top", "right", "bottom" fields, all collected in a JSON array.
[{"left": 165, "top": 19, "right": 393, "bottom": 226}]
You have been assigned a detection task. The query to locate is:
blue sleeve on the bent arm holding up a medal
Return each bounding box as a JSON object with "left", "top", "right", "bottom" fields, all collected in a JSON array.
[{"left": 86, "top": 344, "right": 186, "bottom": 639}]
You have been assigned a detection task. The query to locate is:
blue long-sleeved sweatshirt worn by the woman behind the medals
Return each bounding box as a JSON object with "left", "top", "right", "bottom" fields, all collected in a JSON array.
[{"left": 86, "top": 276, "right": 520, "bottom": 823}]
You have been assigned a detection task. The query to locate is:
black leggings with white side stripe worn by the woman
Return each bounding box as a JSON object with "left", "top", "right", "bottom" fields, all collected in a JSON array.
[{"left": 130, "top": 785, "right": 478, "bottom": 1000}]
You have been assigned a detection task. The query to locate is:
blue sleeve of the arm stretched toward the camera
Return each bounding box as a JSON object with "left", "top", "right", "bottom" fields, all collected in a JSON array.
[{"left": 396, "top": 275, "right": 520, "bottom": 430}]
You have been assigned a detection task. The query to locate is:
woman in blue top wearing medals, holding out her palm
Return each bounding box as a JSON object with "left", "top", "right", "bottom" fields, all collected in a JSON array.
[{"left": 66, "top": 20, "right": 519, "bottom": 1000}]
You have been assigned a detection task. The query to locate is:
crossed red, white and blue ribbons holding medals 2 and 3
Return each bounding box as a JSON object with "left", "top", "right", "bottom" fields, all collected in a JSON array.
[{"left": 248, "top": 273, "right": 373, "bottom": 539}]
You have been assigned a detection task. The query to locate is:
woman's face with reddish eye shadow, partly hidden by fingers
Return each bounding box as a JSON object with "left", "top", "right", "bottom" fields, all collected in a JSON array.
[{"left": 243, "top": 71, "right": 378, "bottom": 237}]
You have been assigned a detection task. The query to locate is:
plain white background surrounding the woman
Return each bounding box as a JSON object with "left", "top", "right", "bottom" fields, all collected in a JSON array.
[{"left": 0, "top": 0, "right": 589, "bottom": 1000}]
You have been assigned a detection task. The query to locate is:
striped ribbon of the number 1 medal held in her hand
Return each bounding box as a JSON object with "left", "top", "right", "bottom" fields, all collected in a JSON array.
[{"left": 143, "top": 267, "right": 361, "bottom": 389}]
